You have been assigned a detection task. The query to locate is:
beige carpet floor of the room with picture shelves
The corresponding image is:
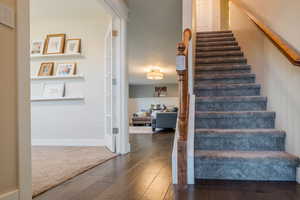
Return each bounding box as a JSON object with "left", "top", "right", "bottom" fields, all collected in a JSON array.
[{"left": 32, "top": 146, "right": 117, "bottom": 197}]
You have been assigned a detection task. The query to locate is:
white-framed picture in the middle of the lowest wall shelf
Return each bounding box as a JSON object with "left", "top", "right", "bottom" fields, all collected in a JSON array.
[{"left": 43, "top": 83, "right": 65, "bottom": 98}]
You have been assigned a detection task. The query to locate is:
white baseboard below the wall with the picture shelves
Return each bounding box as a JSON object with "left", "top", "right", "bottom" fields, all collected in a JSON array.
[{"left": 32, "top": 139, "right": 106, "bottom": 146}]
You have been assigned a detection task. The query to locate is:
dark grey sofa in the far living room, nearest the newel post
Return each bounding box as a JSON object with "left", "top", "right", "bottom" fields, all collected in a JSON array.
[{"left": 151, "top": 112, "right": 177, "bottom": 132}]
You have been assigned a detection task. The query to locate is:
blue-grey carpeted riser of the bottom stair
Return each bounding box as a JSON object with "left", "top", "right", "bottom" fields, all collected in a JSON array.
[{"left": 195, "top": 158, "right": 296, "bottom": 181}]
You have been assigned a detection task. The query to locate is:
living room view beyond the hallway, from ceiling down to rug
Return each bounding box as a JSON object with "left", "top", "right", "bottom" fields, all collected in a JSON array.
[{"left": 128, "top": 0, "right": 182, "bottom": 138}]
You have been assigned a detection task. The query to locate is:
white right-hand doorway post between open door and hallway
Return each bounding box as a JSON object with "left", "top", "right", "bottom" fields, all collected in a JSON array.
[{"left": 98, "top": 0, "right": 130, "bottom": 154}]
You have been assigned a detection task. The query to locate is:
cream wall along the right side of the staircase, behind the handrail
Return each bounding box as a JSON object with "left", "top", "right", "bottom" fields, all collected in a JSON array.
[{"left": 230, "top": 0, "right": 300, "bottom": 156}]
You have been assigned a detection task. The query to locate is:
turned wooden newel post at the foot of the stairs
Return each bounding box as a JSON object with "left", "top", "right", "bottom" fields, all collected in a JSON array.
[{"left": 177, "top": 29, "right": 192, "bottom": 185}]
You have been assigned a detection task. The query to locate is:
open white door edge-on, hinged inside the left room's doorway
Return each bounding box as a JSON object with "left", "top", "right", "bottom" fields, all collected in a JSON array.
[{"left": 105, "top": 22, "right": 116, "bottom": 152}]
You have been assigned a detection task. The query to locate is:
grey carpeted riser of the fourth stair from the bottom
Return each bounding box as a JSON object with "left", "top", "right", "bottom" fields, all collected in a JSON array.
[{"left": 195, "top": 96, "right": 267, "bottom": 111}]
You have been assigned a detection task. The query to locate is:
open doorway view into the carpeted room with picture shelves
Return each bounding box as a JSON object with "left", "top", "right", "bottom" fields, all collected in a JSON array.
[{"left": 30, "top": 0, "right": 123, "bottom": 199}]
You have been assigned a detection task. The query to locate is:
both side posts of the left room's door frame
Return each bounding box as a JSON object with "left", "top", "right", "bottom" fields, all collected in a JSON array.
[{"left": 16, "top": 0, "right": 130, "bottom": 200}]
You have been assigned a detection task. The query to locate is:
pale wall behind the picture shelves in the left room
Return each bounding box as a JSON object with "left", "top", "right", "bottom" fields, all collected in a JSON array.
[{"left": 31, "top": 4, "right": 111, "bottom": 145}]
